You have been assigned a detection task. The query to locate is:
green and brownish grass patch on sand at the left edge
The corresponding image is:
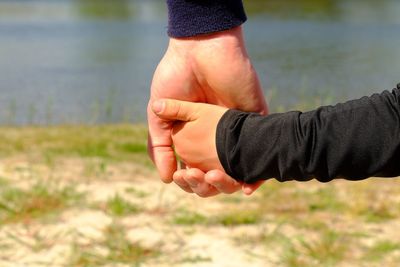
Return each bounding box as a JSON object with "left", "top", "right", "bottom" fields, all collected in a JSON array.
[{"left": 0, "top": 182, "right": 83, "bottom": 223}]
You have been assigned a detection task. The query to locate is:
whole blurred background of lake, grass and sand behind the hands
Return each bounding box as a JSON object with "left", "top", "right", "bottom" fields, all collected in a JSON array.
[{"left": 0, "top": 0, "right": 400, "bottom": 267}]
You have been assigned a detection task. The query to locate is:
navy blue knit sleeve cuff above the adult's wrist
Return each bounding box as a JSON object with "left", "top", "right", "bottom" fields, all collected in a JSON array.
[{"left": 167, "top": 0, "right": 247, "bottom": 38}]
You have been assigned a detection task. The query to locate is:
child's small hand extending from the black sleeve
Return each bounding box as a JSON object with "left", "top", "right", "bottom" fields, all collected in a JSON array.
[{"left": 152, "top": 99, "right": 228, "bottom": 172}]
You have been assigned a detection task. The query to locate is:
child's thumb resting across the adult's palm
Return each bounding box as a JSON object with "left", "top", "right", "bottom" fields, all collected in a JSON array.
[{"left": 152, "top": 99, "right": 199, "bottom": 121}]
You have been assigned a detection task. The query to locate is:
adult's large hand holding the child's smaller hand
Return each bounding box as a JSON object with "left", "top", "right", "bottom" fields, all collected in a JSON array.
[{"left": 147, "top": 27, "right": 267, "bottom": 197}]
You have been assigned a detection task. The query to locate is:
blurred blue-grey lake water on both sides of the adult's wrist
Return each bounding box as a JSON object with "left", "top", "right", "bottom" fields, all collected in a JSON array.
[{"left": 0, "top": 0, "right": 400, "bottom": 125}]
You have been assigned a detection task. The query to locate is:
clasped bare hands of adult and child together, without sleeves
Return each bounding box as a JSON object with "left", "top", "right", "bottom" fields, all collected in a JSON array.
[{"left": 147, "top": 27, "right": 267, "bottom": 197}]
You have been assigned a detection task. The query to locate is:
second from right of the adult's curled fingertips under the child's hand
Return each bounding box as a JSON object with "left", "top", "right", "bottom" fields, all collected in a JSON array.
[{"left": 204, "top": 170, "right": 241, "bottom": 194}]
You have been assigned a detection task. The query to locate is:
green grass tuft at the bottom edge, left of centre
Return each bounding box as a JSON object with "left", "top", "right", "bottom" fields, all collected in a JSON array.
[{"left": 68, "top": 222, "right": 160, "bottom": 266}]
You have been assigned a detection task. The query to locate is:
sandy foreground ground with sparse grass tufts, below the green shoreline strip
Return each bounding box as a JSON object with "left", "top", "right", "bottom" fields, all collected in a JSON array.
[{"left": 0, "top": 157, "right": 400, "bottom": 267}]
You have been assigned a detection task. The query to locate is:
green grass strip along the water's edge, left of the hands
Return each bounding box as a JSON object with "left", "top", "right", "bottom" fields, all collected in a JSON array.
[{"left": 0, "top": 124, "right": 150, "bottom": 166}]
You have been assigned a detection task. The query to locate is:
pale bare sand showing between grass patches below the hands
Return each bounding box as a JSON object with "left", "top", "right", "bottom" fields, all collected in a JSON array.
[{"left": 0, "top": 158, "right": 400, "bottom": 267}]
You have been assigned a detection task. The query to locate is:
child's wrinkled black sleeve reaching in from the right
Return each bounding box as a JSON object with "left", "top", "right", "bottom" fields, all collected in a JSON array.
[{"left": 216, "top": 84, "right": 400, "bottom": 183}]
